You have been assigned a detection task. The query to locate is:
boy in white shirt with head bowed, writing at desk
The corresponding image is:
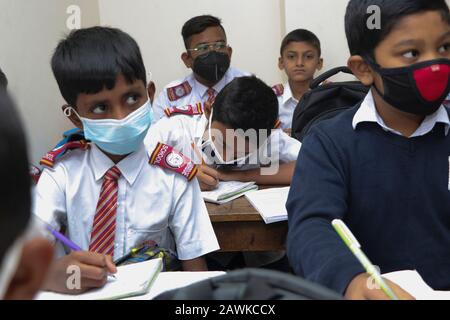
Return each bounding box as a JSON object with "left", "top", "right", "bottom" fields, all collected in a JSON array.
[{"left": 144, "top": 77, "right": 301, "bottom": 190}]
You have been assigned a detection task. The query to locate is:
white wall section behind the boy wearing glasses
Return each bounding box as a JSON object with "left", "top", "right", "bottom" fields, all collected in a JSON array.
[{"left": 99, "top": 0, "right": 283, "bottom": 91}]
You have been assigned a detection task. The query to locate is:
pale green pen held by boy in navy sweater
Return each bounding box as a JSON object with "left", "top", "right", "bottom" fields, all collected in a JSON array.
[{"left": 331, "top": 219, "right": 398, "bottom": 300}]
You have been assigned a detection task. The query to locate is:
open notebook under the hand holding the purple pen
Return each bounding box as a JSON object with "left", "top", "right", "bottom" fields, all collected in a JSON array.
[{"left": 36, "top": 259, "right": 162, "bottom": 300}]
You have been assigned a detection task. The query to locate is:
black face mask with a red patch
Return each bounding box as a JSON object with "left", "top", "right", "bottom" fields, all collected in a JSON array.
[{"left": 367, "top": 59, "right": 450, "bottom": 116}]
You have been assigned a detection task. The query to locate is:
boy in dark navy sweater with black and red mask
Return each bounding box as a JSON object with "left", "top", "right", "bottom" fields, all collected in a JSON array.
[{"left": 286, "top": 0, "right": 450, "bottom": 299}]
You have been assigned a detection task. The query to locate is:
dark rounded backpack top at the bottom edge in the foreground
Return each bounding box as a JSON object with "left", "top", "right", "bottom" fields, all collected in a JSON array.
[{"left": 156, "top": 269, "right": 343, "bottom": 300}]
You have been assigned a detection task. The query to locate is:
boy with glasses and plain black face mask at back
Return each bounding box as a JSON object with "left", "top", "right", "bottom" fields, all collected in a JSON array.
[{"left": 153, "top": 15, "right": 248, "bottom": 122}]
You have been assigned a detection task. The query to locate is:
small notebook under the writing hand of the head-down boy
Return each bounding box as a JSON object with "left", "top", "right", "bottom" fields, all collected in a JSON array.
[{"left": 202, "top": 181, "right": 258, "bottom": 204}]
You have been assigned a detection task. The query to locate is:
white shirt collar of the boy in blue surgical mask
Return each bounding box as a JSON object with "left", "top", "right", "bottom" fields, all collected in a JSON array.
[{"left": 90, "top": 143, "right": 148, "bottom": 185}]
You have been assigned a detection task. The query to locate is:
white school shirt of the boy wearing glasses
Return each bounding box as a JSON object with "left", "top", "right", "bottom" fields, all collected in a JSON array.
[{"left": 153, "top": 67, "right": 249, "bottom": 123}]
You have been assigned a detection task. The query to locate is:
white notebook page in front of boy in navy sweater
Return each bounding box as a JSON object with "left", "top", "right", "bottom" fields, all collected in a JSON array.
[{"left": 383, "top": 270, "right": 450, "bottom": 300}]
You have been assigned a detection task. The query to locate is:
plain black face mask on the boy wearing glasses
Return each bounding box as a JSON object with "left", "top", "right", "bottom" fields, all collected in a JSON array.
[{"left": 193, "top": 51, "right": 231, "bottom": 83}]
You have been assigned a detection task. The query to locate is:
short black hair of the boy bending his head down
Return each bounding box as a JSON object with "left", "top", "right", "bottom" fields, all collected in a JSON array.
[{"left": 212, "top": 76, "right": 278, "bottom": 132}]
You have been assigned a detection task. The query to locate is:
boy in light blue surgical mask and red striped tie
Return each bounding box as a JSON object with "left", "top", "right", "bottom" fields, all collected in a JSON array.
[{"left": 34, "top": 27, "right": 219, "bottom": 294}]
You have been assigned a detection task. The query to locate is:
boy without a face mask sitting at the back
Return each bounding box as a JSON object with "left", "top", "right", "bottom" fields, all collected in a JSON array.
[{"left": 272, "top": 29, "right": 323, "bottom": 133}]
